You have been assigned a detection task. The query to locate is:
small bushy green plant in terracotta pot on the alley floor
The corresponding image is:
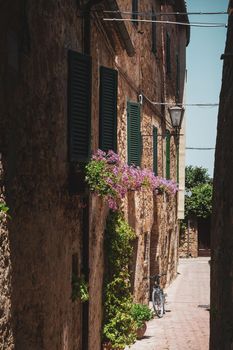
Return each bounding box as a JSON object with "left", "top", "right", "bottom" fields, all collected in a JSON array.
[{"left": 131, "top": 304, "right": 153, "bottom": 339}]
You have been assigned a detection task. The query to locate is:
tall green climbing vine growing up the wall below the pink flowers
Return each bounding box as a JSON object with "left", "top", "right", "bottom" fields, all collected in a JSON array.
[{"left": 103, "top": 213, "right": 137, "bottom": 349}]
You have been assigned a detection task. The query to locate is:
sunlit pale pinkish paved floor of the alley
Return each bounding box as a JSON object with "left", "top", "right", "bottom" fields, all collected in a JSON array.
[{"left": 127, "top": 258, "right": 210, "bottom": 350}]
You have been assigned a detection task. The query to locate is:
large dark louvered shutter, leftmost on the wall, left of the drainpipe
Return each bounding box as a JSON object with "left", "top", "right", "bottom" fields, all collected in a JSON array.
[{"left": 68, "top": 51, "right": 91, "bottom": 162}]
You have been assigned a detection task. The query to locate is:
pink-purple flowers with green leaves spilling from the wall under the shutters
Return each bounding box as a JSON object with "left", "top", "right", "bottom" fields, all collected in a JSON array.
[{"left": 86, "top": 150, "right": 178, "bottom": 210}]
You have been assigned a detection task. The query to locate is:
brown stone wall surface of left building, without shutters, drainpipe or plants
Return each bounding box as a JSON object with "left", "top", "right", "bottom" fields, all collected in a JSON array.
[{"left": 0, "top": 0, "right": 188, "bottom": 350}]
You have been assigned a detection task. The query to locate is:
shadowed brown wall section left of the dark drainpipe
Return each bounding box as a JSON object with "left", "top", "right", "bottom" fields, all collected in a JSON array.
[{"left": 0, "top": 1, "right": 83, "bottom": 350}]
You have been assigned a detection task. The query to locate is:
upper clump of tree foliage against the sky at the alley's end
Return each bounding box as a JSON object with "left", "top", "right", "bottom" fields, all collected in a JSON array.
[{"left": 185, "top": 165, "right": 212, "bottom": 190}]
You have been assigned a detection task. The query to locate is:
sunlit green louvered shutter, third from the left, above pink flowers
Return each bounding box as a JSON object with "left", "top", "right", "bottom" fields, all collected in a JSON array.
[{"left": 127, "top": 102, "right": 141, "bottom": 166}]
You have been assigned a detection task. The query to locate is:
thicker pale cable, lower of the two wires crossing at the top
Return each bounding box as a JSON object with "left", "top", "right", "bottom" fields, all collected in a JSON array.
[{"left": 103, "top": 18, "right": 227, "bottom": 28}]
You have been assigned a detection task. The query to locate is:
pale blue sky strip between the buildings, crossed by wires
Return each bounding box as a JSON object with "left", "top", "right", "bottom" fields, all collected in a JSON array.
[{"left": 186, "top": 0, "right": 228, "bottom": 177}]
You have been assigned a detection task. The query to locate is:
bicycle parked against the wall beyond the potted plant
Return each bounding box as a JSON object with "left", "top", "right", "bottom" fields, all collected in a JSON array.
[{"left": 150, "top": 273, "right": 166, "bottom": 318}]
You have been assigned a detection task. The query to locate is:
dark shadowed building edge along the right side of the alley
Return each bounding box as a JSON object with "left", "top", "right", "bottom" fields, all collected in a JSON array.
[{"left": 210, "top": 0, "right": 233, "bottom": 350}]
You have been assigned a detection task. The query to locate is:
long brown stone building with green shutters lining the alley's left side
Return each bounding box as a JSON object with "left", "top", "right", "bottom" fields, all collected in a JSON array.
[{"left": 0, "top": 0, "right": 189, "bottom": 350}]
